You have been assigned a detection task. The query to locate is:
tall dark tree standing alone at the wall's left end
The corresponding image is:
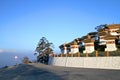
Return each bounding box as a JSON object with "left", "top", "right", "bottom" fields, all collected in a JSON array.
[{"left": 34, "top": 37, "right": 53, "bottom": 63}]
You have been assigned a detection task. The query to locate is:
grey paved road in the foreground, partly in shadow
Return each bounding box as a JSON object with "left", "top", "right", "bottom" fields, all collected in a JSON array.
[{"left": 0, "top": 64, "right": 120, "bottom": 80}]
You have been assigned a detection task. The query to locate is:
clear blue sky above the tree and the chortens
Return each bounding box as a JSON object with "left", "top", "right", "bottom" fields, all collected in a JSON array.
[{"left": 0, "top": 0, "right": 120, "bottom": 51}]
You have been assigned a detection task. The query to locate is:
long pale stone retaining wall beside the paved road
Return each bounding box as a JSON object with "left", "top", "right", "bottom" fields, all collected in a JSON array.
[{"left": 49, "top": 57, "right": 120, "bottom": 69}]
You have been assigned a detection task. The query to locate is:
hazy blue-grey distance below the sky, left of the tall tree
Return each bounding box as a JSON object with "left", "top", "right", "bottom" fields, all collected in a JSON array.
[{"left": 0, "top": 52, "right": 36, "bottom": 68}]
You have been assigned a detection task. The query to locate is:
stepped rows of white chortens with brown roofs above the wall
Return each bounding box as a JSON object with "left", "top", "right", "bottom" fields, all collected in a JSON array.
[{"left": 59, "top": 24, "right": 120, "bottom": 54}]
